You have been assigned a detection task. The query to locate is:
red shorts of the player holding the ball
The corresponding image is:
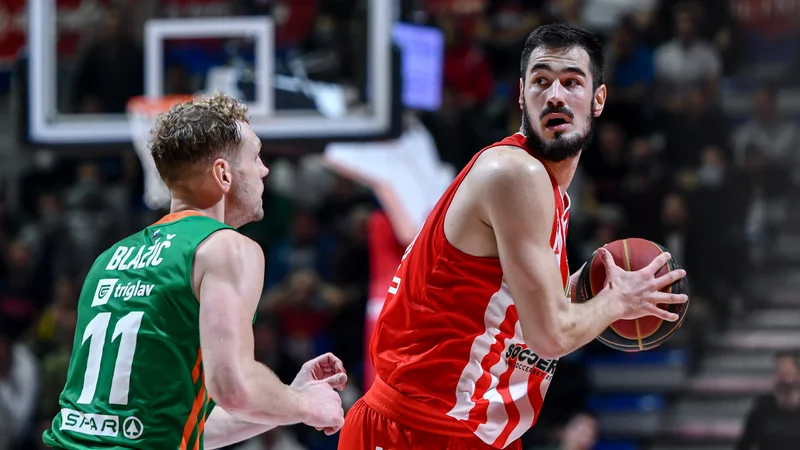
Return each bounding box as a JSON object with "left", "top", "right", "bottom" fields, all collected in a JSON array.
[{"left": 339, "top": 377, "right": 522, "bottom": 450}]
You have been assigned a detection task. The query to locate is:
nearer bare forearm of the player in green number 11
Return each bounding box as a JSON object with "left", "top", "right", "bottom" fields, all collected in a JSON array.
[{"left": 218, "top": 360, "right": 311, "bottom": 426}]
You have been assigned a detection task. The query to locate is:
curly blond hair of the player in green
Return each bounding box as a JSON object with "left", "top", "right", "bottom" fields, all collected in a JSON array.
[{"left": 150, "top": 92, "right": 249, "bottom": 186}]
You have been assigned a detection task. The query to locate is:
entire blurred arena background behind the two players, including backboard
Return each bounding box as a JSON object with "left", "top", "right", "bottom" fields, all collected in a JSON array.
[{"left": 0, "top": 0, "right": 800, "bottom": 450}]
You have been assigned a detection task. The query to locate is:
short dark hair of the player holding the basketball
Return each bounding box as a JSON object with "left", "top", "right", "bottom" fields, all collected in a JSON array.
[{"left": 519, "top": 23, "right": 606, "bottom": 88}]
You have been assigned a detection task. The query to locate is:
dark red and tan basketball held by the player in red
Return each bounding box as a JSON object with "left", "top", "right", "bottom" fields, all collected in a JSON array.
[{"left": 575, "top": 238, "right": 689, "bottom": 352}]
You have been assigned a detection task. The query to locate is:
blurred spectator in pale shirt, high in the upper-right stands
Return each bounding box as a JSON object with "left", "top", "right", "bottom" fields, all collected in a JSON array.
[{"left": 655, "top": 4, "right": 722, "bottom": 111}]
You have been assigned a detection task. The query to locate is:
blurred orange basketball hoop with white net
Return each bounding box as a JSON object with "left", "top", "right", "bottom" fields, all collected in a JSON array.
[{"left": 127, "top": 95, "right": 194, "bottom": 209}]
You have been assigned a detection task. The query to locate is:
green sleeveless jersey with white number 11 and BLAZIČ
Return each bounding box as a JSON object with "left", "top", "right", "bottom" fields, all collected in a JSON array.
[{"left": 43, "top": 212, "right": 230, "bottom": 450}]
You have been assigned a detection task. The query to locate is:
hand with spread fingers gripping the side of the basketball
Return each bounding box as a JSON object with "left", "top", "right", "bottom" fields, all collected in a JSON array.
[{"left": 598, "top": 248, "right": 689, "bottom": 322}]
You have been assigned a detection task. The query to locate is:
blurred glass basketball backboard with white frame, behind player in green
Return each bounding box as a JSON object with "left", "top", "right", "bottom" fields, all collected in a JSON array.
[{"left": 23, "top": 0, "right": 393, "bottom": 146}]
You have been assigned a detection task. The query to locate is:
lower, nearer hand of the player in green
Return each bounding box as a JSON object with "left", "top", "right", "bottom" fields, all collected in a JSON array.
[{"left": 298, "top": 374, "right": 344, "bottom": 436}]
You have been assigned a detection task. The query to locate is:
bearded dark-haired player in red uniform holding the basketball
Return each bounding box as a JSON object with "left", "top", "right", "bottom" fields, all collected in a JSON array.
[{"left": 339, "top": 25, "right": 687, "bottom": 450}]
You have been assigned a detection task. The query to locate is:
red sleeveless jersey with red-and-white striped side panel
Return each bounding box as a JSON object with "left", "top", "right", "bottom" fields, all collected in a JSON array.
[{"left": 370, "top": 134, "right": 569, "bottom": 448}]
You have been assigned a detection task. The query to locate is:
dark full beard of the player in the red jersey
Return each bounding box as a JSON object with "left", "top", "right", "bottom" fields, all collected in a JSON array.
[{"left": 522, "top": 100, "right": 597, "bottom": 162}]
